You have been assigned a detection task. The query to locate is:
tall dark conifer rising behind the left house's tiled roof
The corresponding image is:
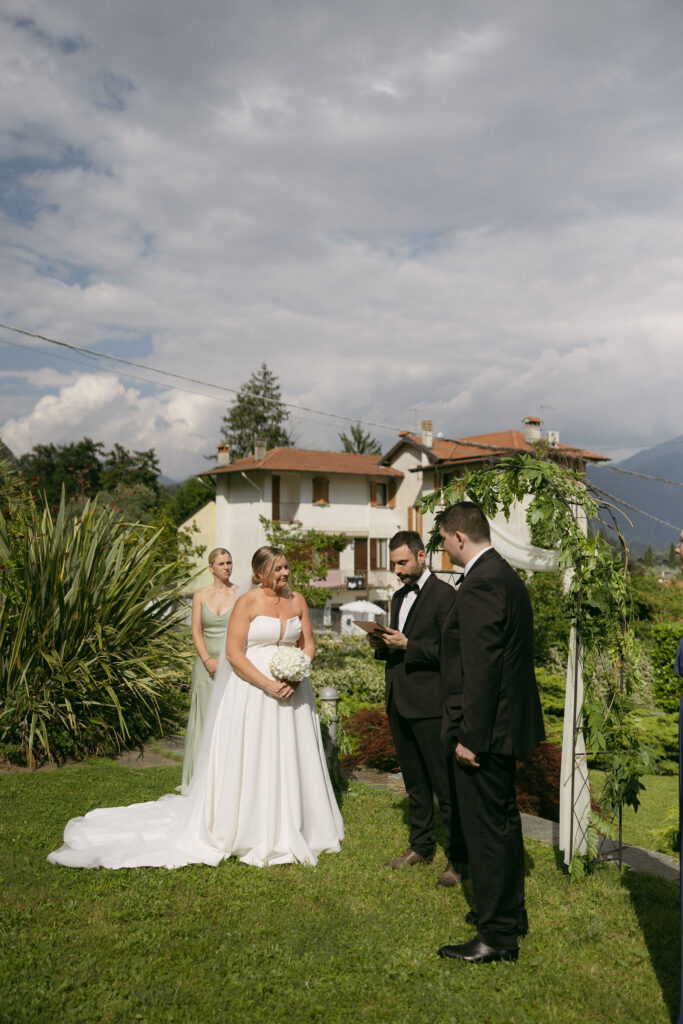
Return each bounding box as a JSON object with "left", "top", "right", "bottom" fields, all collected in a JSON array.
[{"left": 220, "top": 362, "right": 294, "bottom": 459}]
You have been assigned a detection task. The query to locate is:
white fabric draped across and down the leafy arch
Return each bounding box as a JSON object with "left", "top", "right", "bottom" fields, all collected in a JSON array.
[{"left": 489, "top": 520, "right": 591, "bottom": 864}]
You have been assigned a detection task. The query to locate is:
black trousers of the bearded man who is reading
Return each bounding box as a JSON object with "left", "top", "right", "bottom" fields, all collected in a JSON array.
[{"left": 388, "top": 700, "right": 467, "bottom": 864}]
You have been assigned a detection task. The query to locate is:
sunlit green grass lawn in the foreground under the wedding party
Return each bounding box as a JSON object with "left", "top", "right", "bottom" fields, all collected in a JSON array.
[{"left": 0, "top": 761, "right": 680, "bottom": 1024}]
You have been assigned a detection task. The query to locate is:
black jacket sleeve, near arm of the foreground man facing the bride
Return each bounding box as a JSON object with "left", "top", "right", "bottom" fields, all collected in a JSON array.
[{"left": 458, "top": 574, "right": 506, "bottom": 754}]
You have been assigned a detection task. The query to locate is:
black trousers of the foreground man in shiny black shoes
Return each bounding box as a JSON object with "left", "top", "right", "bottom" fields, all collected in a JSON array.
[{"left": 454, "top": 754, "right": 528, "bottom": 949}]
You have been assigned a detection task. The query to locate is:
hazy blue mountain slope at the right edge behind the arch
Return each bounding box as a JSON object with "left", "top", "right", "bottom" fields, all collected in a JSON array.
[{"left": 586, "top": 435, "right": 683, "bottom": 555}]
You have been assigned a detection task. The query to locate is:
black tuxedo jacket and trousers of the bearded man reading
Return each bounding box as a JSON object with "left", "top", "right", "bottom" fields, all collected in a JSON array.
[{"left": 376, "top": 574, "right": 467, "bottom": 862}]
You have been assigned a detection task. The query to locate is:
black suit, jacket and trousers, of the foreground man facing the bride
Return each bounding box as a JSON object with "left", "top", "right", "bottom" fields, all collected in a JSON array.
[{"left": 441, "top": 548, "right": 545, "bottom": 948}]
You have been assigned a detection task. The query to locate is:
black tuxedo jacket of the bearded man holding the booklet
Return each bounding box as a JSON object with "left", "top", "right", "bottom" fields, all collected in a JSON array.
[{"left": 375, "top": 575, "right": 455, "bottom": 718}]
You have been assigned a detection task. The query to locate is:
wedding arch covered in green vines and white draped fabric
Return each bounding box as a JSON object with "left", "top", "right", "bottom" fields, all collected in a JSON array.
[{"left": 423, "top": 454, "right": 650, "bottom": 874}]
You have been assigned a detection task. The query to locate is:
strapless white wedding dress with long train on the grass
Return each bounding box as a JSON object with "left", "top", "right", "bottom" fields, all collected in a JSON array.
[{"left": 47, "top": 615, "right": 344, "bottom": 867}]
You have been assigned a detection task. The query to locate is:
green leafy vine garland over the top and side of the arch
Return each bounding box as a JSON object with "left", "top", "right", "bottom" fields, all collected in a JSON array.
[{"left": 423, "top": 454, "right": 653, "bottom": 874}]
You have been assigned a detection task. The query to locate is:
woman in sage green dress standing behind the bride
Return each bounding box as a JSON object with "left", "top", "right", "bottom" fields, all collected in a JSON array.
[{"left": 180, "top": 548, "right": 239, "bottom": 793}]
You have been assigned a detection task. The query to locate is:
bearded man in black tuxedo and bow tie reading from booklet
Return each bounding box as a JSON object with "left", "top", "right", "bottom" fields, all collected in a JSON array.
[{"left": 368, "top": 530, "right": 467, "bottom": 888}]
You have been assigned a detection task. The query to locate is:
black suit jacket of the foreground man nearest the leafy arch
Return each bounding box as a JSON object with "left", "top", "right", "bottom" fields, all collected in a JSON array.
[{"left": 441, "top": 549, "right": 545, "bottom": 758}]
